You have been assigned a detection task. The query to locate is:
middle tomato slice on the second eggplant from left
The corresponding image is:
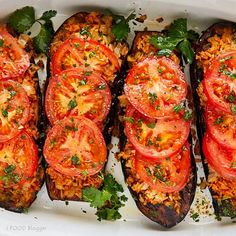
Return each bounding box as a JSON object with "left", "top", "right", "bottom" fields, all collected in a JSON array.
[{"left": 45, "top": 69, "right": 111, "bottom": 126}]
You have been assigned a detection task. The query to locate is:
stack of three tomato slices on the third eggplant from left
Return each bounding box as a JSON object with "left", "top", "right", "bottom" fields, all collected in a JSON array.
[{"left": 124, "top": 57, "right": 190, "bottom": 193}]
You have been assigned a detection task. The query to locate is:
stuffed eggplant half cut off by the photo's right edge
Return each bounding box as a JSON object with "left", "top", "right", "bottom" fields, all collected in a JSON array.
[{"left": 191, "top": 22, "right": 236, "bottom": 218}]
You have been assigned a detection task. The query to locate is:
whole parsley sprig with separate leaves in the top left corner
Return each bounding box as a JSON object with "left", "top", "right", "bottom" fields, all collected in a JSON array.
[{"left": 7, "top": 6, "right": 57, "bottom": 53}]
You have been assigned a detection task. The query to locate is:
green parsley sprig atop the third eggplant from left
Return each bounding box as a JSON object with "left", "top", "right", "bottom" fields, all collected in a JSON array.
[{"left": 150, "top": 18, "right": 199, "bottom": 64}]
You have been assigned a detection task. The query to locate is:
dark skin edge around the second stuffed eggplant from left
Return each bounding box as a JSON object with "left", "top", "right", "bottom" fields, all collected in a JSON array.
[{"left": 43, "top": 12, "right": 128, "bottom": 201}]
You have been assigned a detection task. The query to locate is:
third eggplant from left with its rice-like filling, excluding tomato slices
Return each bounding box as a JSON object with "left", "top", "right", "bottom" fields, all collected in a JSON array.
[{"left": 116, "top": 31, "right": 197, "bottom": 228}]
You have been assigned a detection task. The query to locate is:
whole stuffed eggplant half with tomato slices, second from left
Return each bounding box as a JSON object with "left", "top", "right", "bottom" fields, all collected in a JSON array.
[{"left": 44, "top": 12, "right": 128, "bottom": 200}]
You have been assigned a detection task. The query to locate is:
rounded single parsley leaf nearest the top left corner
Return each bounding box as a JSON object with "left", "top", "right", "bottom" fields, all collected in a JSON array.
[{"left": 8, "top": 6, "right": 35, "bottom": 33}]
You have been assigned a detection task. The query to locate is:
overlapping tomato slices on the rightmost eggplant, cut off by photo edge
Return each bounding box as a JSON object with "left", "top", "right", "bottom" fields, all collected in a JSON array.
[{"left": 203, "top": 51, "right": 236, "bottom": 180}]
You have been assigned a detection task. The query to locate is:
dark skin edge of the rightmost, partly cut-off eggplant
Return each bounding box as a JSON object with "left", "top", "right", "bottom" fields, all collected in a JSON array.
[{"left": 190, "top": 21, "right": 236, "bottom": 218}]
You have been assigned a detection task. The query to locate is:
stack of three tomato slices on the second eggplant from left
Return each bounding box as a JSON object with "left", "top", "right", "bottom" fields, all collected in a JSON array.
[{"left": 44, "top": 35, "right": 120, "bottom": 178}]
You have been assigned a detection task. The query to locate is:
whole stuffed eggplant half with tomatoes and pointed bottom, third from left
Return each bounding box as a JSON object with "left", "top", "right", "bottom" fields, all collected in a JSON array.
[{"left": 117, "top": 32, "right": 196, "bottom": 228}]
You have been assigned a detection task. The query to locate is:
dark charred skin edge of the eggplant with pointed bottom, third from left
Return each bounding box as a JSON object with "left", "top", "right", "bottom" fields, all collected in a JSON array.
[{"left": 115, "top": 31, "right": 197, "bottom": 228}]
